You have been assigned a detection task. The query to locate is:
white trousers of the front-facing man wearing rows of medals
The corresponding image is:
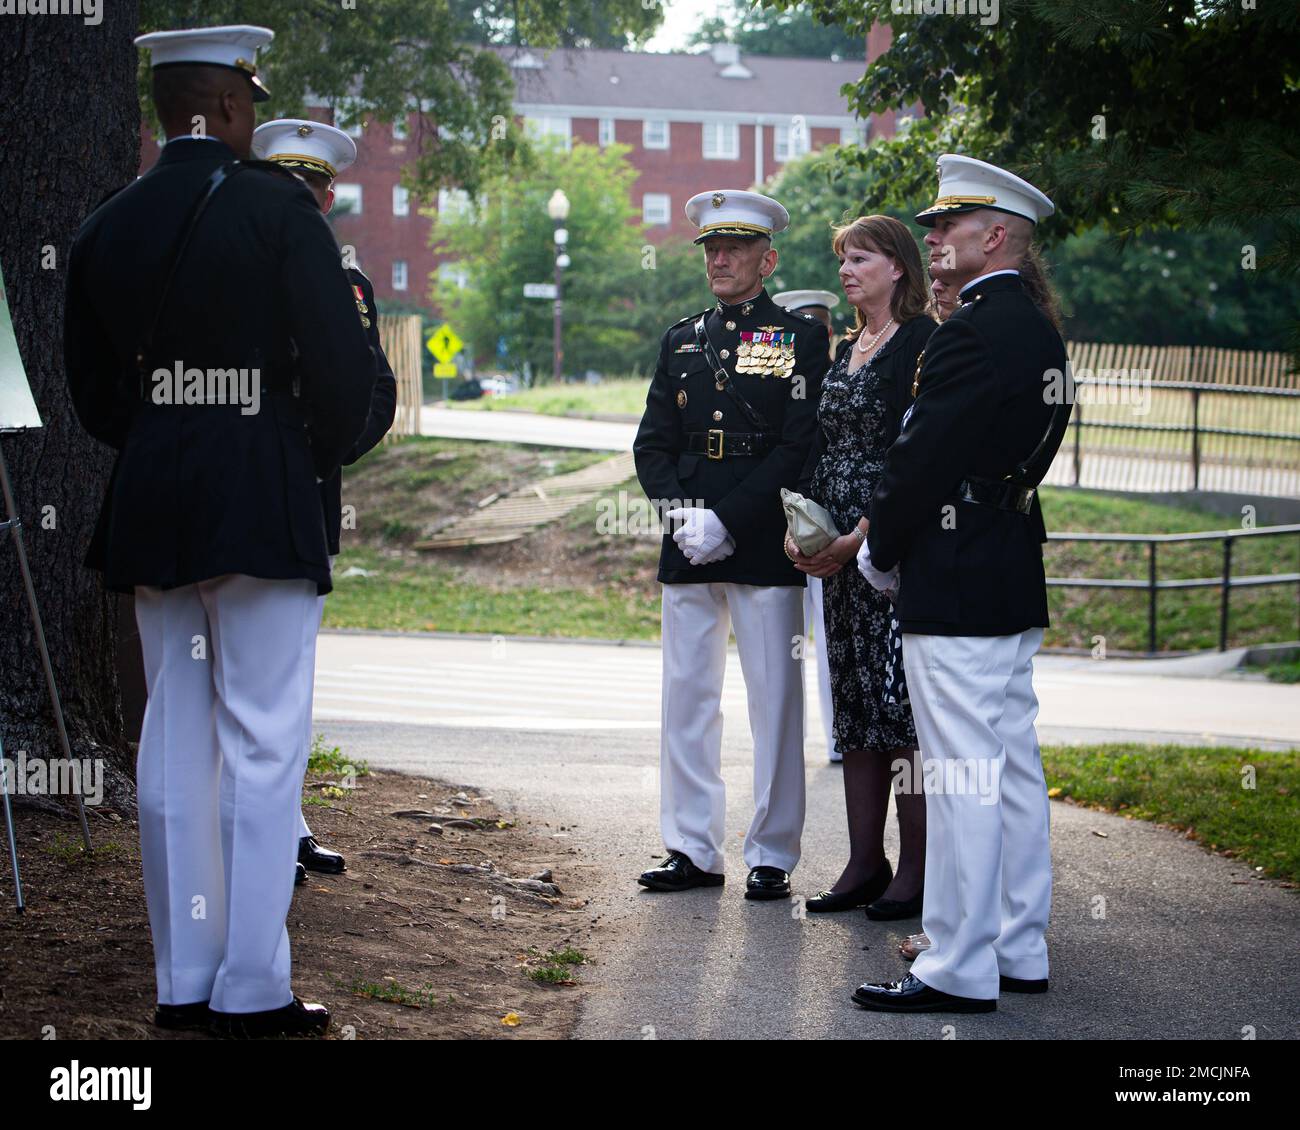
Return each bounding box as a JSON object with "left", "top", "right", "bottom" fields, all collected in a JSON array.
[{"left": 659, "top": 584, "right": 805, "bottom": 873}]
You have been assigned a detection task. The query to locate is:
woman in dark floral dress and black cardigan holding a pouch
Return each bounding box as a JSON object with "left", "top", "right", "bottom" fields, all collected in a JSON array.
[{"left": 785, "top": 216, "right": 935, "bottom": 919}]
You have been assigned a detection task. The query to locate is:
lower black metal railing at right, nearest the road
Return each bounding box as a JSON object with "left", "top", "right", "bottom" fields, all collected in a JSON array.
[{"left": 1048, "top": 524, "right": 1300, "bottom": 657}]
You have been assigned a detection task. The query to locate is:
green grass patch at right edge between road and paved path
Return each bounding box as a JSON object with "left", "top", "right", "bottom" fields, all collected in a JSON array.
[{"left": 1043, "top": 744, "right": 1300, "bottom": 883}]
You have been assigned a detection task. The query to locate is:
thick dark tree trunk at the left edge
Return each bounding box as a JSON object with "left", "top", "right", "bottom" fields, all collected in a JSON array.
[{"left": 0, "top": 0, "right": 140, "bottom": 804}]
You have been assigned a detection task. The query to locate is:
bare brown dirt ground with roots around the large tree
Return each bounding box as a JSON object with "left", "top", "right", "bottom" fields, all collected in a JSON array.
[{"left": 0, "top": 772, "right": 592, "bottom": 1039}]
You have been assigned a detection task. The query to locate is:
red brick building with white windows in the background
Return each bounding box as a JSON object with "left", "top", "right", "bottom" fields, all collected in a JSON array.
[{"left": 140, "top": 39, "right": 893, "bottom": 319}]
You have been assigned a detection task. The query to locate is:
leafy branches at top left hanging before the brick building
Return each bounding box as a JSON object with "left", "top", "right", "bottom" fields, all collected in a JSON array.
[{"left": 140, "top": 0, "right": 662, "bottom": 199}]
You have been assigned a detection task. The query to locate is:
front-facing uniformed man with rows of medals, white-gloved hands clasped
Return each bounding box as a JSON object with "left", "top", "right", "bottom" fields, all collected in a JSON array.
[{"left": 633, "top": 190, "right": 829, "bottom": 899}]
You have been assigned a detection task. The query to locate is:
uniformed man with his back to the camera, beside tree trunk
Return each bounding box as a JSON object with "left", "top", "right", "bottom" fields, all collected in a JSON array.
[{"left": 65, "top": 25, "right": 374, "bottom": 1036}]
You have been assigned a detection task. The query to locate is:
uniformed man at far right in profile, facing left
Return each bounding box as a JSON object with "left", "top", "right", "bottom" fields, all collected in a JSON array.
[{"left": 854, "top": 155, "right": 1071, "bottom": 1012}]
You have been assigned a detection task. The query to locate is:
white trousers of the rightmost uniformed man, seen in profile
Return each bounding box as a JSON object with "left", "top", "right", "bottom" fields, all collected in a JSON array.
[{"left": 902, "top": 628, "right": 1052, "bottom": 1000}]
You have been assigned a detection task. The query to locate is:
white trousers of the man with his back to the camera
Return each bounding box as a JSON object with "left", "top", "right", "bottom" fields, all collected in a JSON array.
[{"left": 135, "top": 575, "right": 319, "bottom": 1013}]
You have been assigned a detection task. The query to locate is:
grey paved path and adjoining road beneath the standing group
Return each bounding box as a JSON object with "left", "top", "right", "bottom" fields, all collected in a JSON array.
[{"left": 316, "top": 633, "right": 1300, "bottom": 1039}]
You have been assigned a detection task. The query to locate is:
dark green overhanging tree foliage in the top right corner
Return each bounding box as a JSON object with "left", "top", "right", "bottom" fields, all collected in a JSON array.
[{"left": 772, "top": 0, "right": 1300, "bottom": 348}]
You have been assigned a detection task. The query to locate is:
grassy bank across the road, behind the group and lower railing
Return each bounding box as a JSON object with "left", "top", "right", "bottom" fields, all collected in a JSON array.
[{"left": 325, "top": 438, "right": 1300, "bottom": 651}]
